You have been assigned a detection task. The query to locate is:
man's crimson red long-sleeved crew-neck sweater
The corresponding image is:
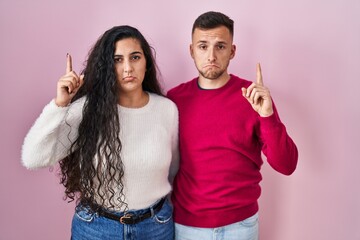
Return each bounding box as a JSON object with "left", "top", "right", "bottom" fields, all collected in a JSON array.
[{"left": 168, "top": 75, "right": 298, "bottom": 228}]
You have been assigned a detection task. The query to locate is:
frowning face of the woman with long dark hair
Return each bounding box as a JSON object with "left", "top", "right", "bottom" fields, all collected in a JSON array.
[{"left": 114, "top": 38, "right": 146, "bottom": 94}]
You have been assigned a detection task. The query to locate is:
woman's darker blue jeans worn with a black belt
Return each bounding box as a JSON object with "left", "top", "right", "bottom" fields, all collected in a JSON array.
[{"left": 71, "top": 199, "right": 174, "bottom": 240}]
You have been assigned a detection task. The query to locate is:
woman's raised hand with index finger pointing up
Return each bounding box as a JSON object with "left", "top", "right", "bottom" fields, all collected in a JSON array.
[{"left": 55, "top": 54, "right": 84, "bottom": 107}]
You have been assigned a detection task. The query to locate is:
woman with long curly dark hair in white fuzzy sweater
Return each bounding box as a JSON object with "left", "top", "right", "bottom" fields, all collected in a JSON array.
[{"left": 22, "top": 26, "right": 178, "bottom": 240}]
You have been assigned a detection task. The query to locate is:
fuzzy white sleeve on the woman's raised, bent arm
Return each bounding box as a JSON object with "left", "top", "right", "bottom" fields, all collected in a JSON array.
[{"left": 21, "top": 100, "right": 82, "bottom": 169}]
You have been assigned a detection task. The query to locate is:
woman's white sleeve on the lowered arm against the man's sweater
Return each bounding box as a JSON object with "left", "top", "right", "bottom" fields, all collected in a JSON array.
[{"left": 169, "top": 104, "right": 180, "bottom": 185}]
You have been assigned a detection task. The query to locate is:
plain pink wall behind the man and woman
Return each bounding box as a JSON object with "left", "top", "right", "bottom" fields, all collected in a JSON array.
[{"left": 0, "top": 0, "right": 360, "bottom": 240}]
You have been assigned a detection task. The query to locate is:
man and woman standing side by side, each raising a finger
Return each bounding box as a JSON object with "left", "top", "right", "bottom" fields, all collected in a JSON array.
[{"left": 22, "top": 12, "right": 298, "bottom": 240}]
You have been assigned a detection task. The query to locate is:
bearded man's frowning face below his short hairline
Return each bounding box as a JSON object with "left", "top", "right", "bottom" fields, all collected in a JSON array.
[{"left": 190, "top": 26, "right": 236, "bottom": 80}]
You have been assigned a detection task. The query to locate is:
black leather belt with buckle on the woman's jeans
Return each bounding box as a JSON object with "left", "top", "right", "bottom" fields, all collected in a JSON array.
[{"left": 98, "top": 197, "right": 166, "bottom": 224}]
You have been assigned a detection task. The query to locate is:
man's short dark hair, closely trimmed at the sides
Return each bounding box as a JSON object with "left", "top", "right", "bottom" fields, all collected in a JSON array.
[{"left": 192, "top": 11, "right": 234, "bottom": 36}]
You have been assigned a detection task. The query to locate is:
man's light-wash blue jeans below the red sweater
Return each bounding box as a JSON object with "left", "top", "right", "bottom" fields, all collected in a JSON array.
[{"left": 175, "top": 213, "right": 259, "bottom": 240}]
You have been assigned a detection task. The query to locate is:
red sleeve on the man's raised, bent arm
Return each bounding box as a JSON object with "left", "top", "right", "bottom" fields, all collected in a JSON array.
[{"left": 259, "top": 101, "right": 298, "bottom": 175}]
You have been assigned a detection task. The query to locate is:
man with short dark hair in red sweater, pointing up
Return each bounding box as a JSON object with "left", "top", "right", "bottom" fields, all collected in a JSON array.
[{"left": 168, "top": 12, "right": 298, "bottom": 240}]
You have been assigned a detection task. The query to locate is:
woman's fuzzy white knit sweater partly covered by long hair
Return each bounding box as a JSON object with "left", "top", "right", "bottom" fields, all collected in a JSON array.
[{"left": 22, "top": 93, "right": 179, "bottom": 210}]
